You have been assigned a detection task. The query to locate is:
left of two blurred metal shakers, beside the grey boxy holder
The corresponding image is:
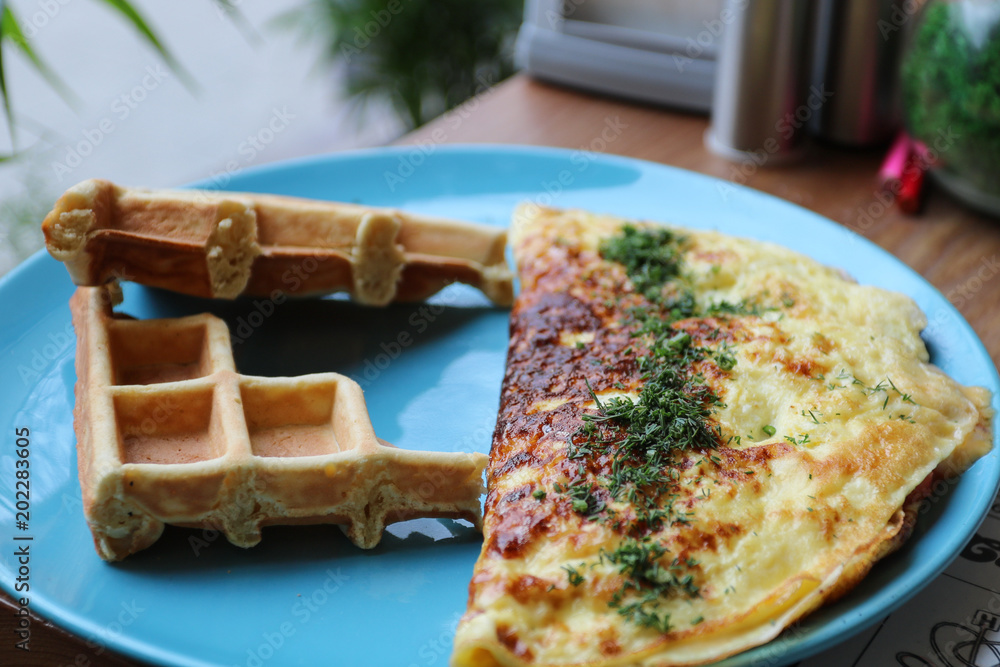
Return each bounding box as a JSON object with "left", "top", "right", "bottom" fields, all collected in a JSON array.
[{"left": 705, "top": 0, "right": 825, "bottom": 165}]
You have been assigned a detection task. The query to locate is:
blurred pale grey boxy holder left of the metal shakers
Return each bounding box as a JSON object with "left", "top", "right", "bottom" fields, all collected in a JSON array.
[{"left": 516, "top": 0, "right": 725, "bottom": 111}]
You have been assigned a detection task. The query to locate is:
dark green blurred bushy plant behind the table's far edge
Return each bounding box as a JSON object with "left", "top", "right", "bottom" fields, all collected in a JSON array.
[{"left": 281, "top": 0, "right": 524, "bottom": 128}]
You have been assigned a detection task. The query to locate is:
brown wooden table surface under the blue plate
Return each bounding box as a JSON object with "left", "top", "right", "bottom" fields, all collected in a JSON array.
[{"left": 0, "top": 75, "right": 1000, "bottom": 667}]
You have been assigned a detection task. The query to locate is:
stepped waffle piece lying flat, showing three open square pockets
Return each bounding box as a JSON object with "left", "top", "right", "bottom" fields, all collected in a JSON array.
[{"left": 70, "top": 287, "right": 486, "bottom": 560}]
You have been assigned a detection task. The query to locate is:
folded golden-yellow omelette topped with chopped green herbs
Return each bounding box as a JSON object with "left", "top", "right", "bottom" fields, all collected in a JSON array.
[{"left": 452, "top": 204, "right": 992, "bottom": 667}]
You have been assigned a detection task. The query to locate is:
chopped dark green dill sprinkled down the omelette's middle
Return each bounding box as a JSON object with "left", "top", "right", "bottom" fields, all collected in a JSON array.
[{"left": 553, "top": 225, "right": 774, "bottom": 632}]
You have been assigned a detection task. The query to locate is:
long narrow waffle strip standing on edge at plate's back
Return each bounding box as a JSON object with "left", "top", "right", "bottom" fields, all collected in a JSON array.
[{"left": 42, "top": 179, "right": 513, "bottom": 305}]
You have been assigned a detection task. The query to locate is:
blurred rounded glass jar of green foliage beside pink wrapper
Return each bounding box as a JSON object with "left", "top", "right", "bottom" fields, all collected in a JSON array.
[{"left": 902, "top": 2, "right": 1000, "bottom": 195}]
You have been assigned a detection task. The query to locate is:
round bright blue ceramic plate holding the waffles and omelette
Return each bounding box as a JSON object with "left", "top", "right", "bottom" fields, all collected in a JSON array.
[{"left": 0, "top": 147, "right": 1000, "bottom": 667}]
